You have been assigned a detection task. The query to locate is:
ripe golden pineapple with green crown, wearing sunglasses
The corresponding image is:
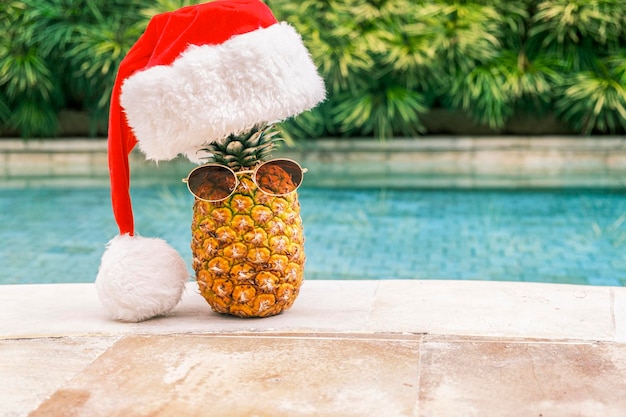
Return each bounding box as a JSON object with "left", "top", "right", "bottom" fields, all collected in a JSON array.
[{"left": 191, "top": 125, "right": 305, "bottom": 317}]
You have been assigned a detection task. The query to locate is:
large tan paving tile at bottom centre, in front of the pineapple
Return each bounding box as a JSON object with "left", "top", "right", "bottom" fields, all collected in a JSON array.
[{"left": 30, "top": 335, "right": 421, "bottom": 417}]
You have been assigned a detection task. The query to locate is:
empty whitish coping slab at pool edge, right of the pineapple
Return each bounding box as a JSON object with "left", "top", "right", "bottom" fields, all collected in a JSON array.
[{"left": 367, "top": 280, "right": 615, "bottom": 341}]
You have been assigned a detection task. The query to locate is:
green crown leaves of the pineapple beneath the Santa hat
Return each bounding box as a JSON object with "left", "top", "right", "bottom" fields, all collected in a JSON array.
[{"left": 202, "top": 124, "right": 283, "bottom": 171}]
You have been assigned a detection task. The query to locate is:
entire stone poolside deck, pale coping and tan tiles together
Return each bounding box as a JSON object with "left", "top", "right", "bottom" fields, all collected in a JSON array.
[{"left": 0, "top": 280, "right": 626, "bottom": 417}]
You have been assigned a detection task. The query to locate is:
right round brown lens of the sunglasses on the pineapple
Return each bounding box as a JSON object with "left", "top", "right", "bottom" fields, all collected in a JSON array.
[{"left": 255, "top": 159, "right": 302, "bottom": 195}]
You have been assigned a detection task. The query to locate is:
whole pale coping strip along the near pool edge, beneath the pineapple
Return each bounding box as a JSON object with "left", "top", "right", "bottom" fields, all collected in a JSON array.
[{"left": 0, "top": 280, "right": 626, "bottom": 343}]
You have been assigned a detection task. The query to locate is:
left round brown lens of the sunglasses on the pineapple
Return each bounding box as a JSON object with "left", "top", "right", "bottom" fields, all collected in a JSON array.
[{"left": 187, "top": 165, "right": 237, "bottom": 201}]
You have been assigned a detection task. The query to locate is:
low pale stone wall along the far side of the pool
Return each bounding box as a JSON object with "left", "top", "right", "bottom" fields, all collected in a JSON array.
[{"left": 0, "top": 136, "right": 626, "bottom": 188}]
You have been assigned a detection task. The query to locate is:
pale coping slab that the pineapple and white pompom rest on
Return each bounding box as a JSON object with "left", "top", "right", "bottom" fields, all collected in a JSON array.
[{"left": 0, "top": 281, "right": 378, "bottom": 337}]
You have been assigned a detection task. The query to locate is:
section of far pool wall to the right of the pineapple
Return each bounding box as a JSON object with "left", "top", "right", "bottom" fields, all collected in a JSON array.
[{"left": 285, "top": 136, "right": 626, "bottom": 187}]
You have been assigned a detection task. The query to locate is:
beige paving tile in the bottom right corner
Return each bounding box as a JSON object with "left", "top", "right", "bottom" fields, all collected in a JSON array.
[{"left": 418, "top": 338, "right": 626, "bottom": 417}]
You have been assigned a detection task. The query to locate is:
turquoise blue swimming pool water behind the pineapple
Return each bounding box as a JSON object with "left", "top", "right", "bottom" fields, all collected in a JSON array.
[{"left": 0, "top": 184, "right": 626, "bottom": 286}]
